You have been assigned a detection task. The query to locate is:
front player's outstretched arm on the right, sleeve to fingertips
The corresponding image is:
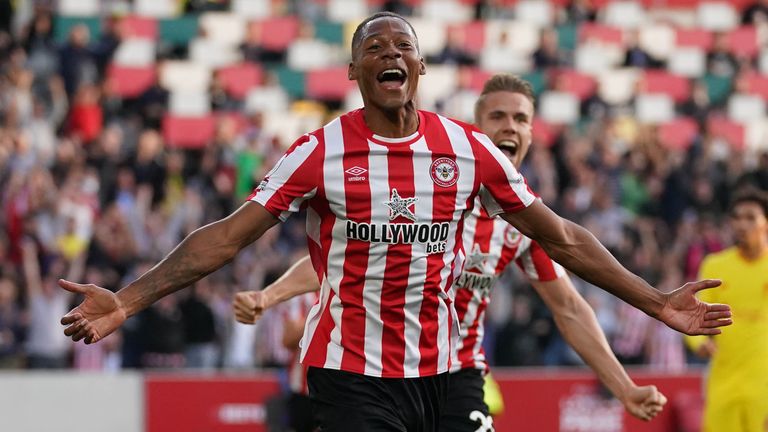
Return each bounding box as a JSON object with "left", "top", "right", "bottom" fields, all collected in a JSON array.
[{"left": 501, "top": 200, "right": 731, "bottom": 334}]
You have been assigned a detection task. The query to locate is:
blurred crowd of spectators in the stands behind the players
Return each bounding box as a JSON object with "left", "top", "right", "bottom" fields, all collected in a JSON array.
[{"left": 0, "top": 0, "right": 768, "bottom": 371}]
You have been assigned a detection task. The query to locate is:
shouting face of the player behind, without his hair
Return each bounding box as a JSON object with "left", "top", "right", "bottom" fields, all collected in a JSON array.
[{"left": 477, "top": 91, "right": 533, "bottom": 167}]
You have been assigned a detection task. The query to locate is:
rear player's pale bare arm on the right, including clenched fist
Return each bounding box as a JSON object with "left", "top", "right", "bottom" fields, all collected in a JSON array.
[{"left": 531, "top": 275, "right": 667, "bottom": 421}]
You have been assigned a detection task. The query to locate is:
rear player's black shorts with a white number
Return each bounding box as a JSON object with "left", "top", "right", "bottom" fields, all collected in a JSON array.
[{"left": 440, "top": 369, "right": 494, "bottom": 432}]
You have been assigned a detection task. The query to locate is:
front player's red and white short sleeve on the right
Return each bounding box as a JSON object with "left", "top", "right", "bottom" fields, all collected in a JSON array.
[{"left": 472, "top": 131, "right": 536, "bottom": 216}]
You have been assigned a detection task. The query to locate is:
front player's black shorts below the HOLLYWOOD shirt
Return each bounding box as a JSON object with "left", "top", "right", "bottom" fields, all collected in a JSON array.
[{"left": 307, "top": 367, "right": 448, "bottom": 432}]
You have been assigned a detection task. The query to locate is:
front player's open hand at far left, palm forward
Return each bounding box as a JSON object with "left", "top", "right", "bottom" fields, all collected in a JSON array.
[{"left": 59, "top": 279, "right": 126, "bottom": 344}]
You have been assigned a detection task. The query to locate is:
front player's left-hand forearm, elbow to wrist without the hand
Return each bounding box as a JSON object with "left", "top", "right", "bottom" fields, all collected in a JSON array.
[{"left": 117, "top": 223, "right": 241, "bottom": 317}]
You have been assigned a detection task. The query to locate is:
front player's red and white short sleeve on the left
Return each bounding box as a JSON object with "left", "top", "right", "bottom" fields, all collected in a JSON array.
[{"left": 248, "top": 134, "right": 322, "bottom": 221}]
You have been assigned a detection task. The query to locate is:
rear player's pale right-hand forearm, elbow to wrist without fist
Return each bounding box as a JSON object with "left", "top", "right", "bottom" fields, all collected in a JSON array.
[{"left": 555, "top": 296, "right": 634, "bottom": 402}]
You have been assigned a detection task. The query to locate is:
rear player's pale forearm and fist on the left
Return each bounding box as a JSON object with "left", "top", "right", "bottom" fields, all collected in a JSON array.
[{"left": 232, "top": 255, "right": 320, "bottom": 324}]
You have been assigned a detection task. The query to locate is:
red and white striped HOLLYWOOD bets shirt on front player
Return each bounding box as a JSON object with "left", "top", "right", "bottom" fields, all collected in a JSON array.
[{"left": 251, "top": 109, "right": 535, "bottom": 378}]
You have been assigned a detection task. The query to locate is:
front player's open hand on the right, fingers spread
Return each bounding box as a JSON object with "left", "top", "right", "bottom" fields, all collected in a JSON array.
[{"left": 658, "top": 279, "right": 733, "bottom": 335}]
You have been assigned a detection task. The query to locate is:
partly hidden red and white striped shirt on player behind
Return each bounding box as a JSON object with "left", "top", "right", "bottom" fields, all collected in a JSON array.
[{"left": 451, "top": 199, "right": 565, "bottom": 372}]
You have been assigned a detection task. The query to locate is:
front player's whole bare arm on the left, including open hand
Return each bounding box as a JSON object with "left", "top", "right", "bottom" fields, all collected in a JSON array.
[{"left": 59, "top": 202, "right": 277, "bottom": 344}]
